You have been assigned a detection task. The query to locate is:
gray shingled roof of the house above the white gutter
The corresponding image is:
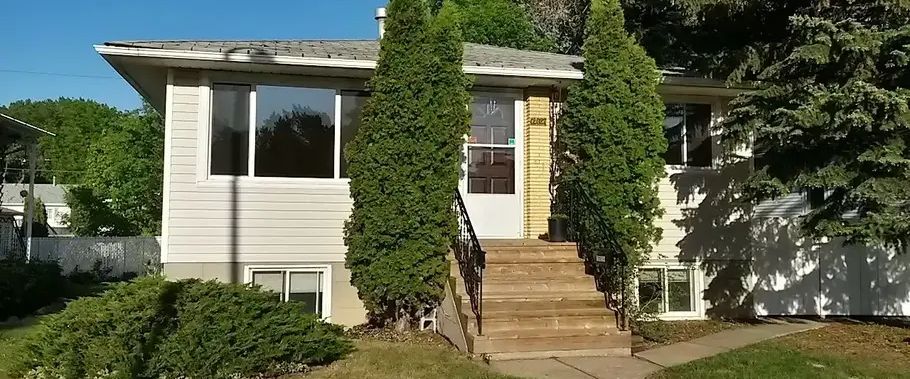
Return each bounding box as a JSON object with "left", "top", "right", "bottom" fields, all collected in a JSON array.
[{"left": 105, "top": 40, "right": 582, "bottom": 71}]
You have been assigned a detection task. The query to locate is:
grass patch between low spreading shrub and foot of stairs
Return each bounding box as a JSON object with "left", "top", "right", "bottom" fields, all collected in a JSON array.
[{"left": 304, "top": 340, "right": 514, "bottom": 379}]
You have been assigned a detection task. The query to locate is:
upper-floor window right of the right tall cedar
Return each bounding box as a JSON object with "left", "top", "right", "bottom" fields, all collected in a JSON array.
[{"left": 664, "top": 103, "right": 712, "bottom": 167}]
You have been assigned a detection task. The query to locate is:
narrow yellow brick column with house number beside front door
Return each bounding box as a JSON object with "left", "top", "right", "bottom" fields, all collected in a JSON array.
[{"left": 524, "top": 88, "right": 551, "bottom": 238}]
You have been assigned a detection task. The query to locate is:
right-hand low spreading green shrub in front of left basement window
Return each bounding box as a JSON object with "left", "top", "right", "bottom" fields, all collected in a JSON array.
[{"left": 149, "top": 281, "right": 350, "bottom": 378}]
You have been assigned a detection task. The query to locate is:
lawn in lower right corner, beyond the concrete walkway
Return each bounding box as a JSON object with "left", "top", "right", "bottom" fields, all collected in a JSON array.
[{"left": 650, "top": 322, "right": 910, "bottom": 379}]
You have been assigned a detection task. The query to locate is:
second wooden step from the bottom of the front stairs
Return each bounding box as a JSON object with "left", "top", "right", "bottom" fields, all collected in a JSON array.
[{"left": 466, "top": 314, "right": 617, "bottom": 335}]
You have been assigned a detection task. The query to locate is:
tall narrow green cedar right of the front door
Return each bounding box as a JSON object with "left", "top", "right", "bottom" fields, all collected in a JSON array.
[{"left": 556, "top": 0, "right": 667, "bottom": 266}]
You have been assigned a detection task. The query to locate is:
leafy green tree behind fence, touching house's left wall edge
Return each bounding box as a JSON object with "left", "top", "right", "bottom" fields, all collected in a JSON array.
[{"left": 66, "top": 104, "right": 164, "bottom": 236}]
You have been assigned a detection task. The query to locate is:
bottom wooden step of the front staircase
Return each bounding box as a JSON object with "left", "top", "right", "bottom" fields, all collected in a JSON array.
[{"left": 468, "top": 330, "right": 631, "bottom": 359}]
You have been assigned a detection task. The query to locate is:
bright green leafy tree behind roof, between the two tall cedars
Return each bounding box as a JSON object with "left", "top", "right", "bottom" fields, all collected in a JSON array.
[{"left": 447, "top": 0, "right": 555, "bottom": 51}]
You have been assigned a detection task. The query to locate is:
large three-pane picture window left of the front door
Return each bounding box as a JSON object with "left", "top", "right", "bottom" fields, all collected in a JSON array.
[{"left": 210, "top": 83, "right": 369, "bottom": 179}]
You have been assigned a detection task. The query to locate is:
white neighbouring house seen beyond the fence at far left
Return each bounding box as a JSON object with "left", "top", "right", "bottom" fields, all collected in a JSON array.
[{"left": 0, "top": 183, "right": 72, "bottom": 236}]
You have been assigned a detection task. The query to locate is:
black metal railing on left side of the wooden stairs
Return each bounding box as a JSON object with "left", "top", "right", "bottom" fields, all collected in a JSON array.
[{"left": 452, "top": 190, "right": 487, "bottom": 335}]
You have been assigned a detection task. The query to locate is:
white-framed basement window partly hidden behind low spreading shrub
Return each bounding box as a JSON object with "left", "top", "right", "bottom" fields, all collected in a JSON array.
[{"left": 247, "top": 266, "right": 331, "bottom": 317}]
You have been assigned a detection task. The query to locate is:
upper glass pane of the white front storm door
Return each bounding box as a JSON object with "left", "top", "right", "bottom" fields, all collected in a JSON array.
[{"left": 468, "top": 95, "right": 515, "bottom": 145}]
